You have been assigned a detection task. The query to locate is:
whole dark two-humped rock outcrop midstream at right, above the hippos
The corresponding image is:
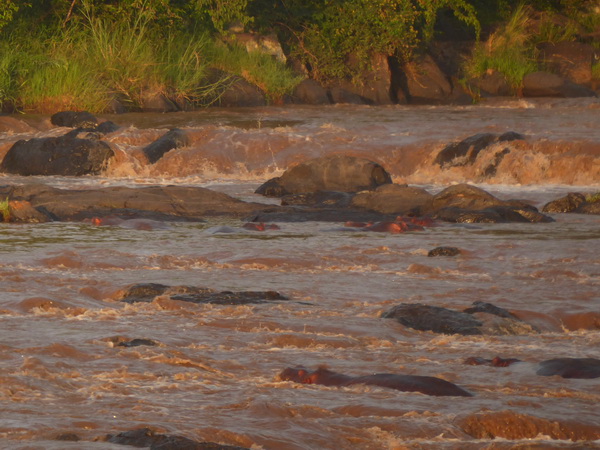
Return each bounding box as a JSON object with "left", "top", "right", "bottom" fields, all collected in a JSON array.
[{"left": 381, "top": 302, "right": 537, "bottom": 336}]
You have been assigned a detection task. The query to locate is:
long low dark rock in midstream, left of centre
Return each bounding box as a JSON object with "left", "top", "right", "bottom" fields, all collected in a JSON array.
[{"left": 114, "top": 283, "right": 288, "bottom": 305}]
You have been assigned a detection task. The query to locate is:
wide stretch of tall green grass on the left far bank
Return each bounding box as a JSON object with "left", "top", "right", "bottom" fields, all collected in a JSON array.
[{"left": 0, "top": 1, "right": 300, "bottom": 113}]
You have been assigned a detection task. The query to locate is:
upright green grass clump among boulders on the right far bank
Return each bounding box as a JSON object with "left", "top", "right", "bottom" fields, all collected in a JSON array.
[{"left": 464, "top": 4, "right": 537, "bottom": 90}]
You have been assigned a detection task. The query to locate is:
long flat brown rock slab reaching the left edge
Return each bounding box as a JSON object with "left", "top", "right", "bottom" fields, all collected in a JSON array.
[{"left": 0, "top": 184, "right": 265, "bottom": 221}]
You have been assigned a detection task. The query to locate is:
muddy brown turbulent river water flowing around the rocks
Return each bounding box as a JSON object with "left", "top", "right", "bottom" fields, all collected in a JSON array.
[{"left": 0, "top": 99, "right": 600, "bottom": 449}]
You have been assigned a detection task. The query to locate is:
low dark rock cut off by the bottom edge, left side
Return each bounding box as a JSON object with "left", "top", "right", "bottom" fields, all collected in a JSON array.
[{"left": 106, "top": 428, "right": 243, "bottom": 450}]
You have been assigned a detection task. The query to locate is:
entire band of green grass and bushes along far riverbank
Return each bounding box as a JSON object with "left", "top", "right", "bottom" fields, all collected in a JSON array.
[{"left": 0, "top": 0, "right": 600, "bottom": 113}]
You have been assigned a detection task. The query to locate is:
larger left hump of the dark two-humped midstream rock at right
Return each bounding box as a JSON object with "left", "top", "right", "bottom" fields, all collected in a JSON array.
[{"left": 381, "top": 303, "right": 483, "bottom": 336}]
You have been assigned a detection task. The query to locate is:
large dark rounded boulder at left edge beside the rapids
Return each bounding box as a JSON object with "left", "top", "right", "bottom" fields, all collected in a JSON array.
[{"left": 0, "top": 136, "right": 114, "bottom": 176}]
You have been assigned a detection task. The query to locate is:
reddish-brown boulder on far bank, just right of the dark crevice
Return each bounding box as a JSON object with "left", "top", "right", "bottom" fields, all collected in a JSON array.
[{"left": 404, "top": 55, "right": 452, "bottom": 104}]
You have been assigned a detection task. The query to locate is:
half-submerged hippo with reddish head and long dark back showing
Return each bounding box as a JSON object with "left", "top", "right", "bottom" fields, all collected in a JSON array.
[{"left": 279, "top": 367, "right": 473, "bottom": 397}]
